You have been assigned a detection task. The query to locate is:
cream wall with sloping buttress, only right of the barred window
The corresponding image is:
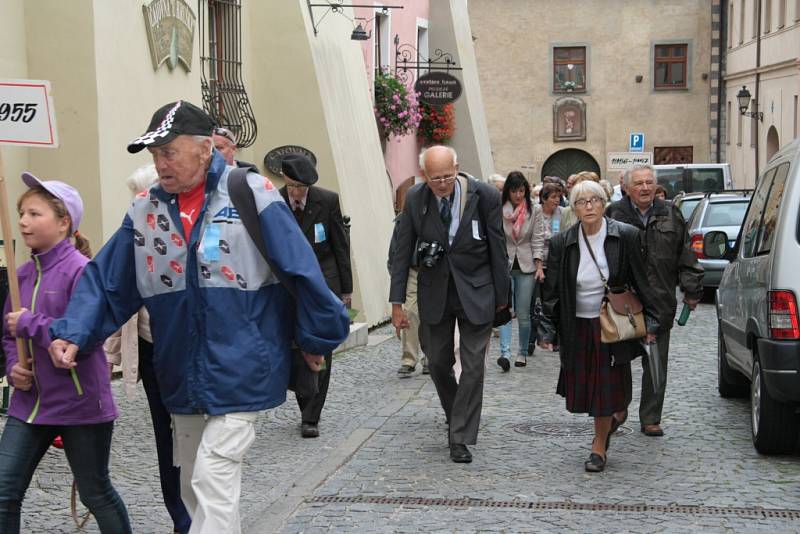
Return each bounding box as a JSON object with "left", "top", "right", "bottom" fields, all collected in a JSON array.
[{"left": 243, "top": 0, "right": 394, "bottom": 324}]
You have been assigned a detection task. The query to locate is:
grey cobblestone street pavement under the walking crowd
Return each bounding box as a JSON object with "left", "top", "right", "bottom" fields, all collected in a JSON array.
[{"left": 6, "top": 304, "right": 800, "bottom": 533}]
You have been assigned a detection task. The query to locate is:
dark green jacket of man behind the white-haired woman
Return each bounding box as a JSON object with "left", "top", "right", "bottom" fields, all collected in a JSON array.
[{"left": 606, "top": 197, "right": 703, "bottom": 332}]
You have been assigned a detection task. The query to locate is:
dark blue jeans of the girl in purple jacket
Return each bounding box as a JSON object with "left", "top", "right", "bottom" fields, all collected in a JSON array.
[{"left": 0, "top": 417, "right": 131, "bottom": 534}]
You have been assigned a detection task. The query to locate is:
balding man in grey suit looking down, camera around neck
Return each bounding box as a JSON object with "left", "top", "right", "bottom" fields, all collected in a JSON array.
[{"left": 389, "top": 146, "right": 511, "bottom": 463}]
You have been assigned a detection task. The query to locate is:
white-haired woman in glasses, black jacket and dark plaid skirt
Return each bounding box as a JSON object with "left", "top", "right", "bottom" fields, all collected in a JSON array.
[{"left": 539, "top": 181, "right": 659, "bottom": 472}]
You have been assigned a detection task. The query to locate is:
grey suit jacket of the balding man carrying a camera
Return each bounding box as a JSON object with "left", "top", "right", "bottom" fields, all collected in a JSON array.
[{"left": 389, "top": 173, "right": 511, "bottom": 324}]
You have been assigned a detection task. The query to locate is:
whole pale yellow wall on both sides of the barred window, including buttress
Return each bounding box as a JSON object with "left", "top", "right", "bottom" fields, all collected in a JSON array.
[{"left": 0, "top": 0, "right": 394, "bottom": 324}]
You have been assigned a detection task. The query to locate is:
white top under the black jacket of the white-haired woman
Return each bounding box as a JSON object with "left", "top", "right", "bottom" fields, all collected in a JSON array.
[{"left": 575, "top": 219, "right": 608, "bottom": 319}]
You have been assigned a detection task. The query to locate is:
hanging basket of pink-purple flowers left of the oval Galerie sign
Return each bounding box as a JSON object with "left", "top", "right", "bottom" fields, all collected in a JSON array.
[{"left": 374, "top": 71, "right": 422, "bottom": 140}]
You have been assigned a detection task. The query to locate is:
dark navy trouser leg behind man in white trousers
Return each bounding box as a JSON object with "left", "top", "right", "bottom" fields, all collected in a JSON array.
[{"left": 139, "top": 337, "right": 192, "bottom": 534}]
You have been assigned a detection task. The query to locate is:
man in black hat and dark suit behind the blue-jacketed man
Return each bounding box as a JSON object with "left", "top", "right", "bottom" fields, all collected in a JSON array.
[{"left": 280, "top": 154, "right": 353, "bottom": 438}]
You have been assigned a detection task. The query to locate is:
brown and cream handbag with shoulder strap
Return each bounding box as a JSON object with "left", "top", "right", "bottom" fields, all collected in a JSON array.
[{"left": 581, "top": 226, "right": 647, "bottom": 343}]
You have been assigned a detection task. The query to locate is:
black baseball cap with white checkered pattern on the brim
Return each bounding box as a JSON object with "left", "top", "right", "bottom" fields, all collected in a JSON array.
[{"left": 128, "top": 100, "right": 214, "bottom": 154}]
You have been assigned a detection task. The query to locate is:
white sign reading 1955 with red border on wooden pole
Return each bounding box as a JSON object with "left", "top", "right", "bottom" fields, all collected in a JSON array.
[{"left": 0, "top": 80, "right": 58, "bottom": 148}]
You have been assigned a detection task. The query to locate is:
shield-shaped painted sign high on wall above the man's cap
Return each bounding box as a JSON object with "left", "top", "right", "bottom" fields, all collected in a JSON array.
[{"left": 142, "top": 0, "right": 196, "bottom": 72}]
